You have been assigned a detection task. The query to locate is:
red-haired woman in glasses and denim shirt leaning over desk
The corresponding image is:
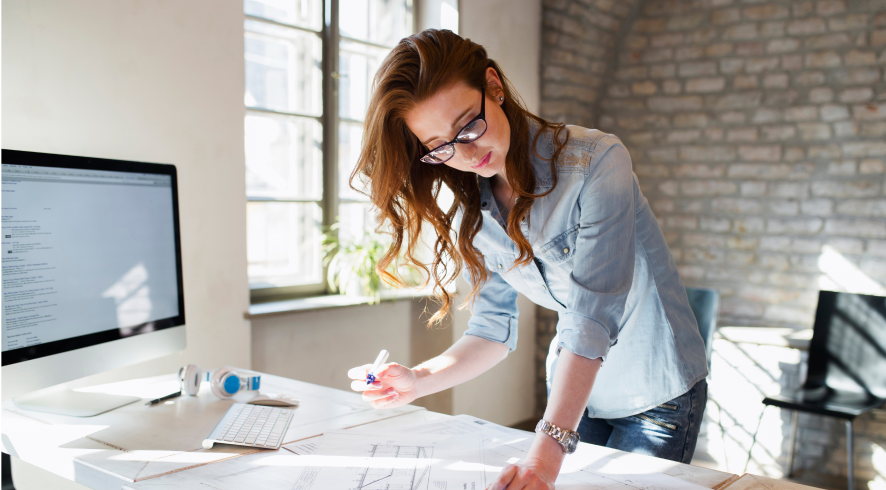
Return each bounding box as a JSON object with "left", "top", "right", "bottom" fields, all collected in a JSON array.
[{"left": 348, "top": 30, "right": 707, "bottom": 490}]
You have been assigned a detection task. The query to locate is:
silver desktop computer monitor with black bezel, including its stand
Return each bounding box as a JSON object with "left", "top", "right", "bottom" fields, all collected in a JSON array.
[{"left": 0, "top": 149, "right": 185, "bottom": 416}]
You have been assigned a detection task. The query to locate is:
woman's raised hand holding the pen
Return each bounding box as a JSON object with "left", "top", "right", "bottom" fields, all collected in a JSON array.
[{"left": 348, "top": 362, "right": 418, "bottom": 408}]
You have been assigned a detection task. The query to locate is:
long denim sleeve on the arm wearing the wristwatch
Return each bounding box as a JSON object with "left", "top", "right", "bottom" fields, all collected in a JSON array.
[{"left": 557, "top": 136, "right": 636, "bottom": 360}]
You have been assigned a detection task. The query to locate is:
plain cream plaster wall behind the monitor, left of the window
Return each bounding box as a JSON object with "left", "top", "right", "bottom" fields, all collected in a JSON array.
[{"left": 0, "top": 0, "right": 251, "bottom": 399}]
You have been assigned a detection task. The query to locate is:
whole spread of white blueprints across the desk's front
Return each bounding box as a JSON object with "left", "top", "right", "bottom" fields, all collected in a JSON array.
[{"left": 124, "top": 415, "right": 709, "bottom": 490}]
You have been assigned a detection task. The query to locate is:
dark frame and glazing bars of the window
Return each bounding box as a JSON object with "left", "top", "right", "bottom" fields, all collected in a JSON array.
[{"left": 243, "top": 0, "right": 421, "bottom": 303}]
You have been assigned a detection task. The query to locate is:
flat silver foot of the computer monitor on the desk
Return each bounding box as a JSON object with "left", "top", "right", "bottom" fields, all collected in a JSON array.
[{"left": 12, "top": 385, "right": 141, "bottom": 417}]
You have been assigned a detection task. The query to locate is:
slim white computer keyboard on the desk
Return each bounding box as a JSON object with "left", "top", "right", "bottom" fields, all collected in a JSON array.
[{"left": 203, "top": 403, "right": 293, "bottom": 449}]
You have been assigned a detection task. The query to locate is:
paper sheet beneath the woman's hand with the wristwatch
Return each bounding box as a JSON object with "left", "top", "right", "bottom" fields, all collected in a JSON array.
[{"left": 387, "top": 415, "right": 707, "bottom": 490}]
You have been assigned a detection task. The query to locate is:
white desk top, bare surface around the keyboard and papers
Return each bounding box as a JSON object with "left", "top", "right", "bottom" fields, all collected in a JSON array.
[{"left": 0, "top": 374, "right": 738, "bottom": 490}]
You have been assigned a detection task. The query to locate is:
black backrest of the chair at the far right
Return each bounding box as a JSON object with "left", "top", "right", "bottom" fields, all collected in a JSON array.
[{"left": 803, "top": 291, "right": 886, "bottom": 399}]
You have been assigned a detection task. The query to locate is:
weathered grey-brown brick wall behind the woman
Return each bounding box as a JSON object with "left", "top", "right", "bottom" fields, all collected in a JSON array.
[{"left": 537, "top": 0, "right": 886, "bottom": 484}]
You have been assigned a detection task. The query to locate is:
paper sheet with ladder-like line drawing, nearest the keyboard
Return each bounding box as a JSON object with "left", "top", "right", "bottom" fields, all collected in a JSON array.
[{"left": 292, "top": 430, "right": 486, "bottom": 490}]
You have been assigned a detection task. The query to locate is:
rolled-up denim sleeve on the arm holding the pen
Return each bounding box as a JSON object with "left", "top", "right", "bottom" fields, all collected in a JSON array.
[{"left": 463, "top": 262, "right": 519, "bottom": 352}]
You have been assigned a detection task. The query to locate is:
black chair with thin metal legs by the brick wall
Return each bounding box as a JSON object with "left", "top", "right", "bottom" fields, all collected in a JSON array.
[{"left": 745, "top": 291, "right": 886, "bottom": 490}]
